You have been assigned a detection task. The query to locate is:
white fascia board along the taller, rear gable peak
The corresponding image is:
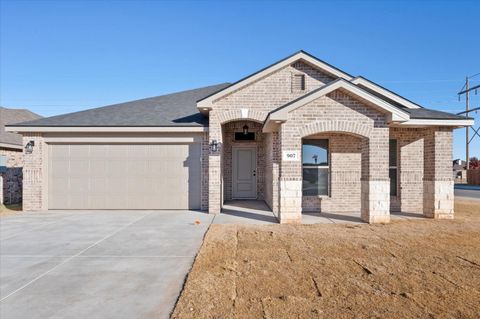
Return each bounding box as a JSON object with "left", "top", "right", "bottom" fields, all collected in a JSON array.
[{"left": 197, "top": 52, "right": 353, "bottom": 112}]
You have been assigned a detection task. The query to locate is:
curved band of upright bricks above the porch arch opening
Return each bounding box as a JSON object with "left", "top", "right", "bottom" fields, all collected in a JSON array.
[{"left": 298, "top": 120, "right": 372, "bottom": 138}]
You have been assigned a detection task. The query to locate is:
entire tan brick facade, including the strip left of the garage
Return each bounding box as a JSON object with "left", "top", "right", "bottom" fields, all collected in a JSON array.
[{"left": 18, "top": 58, "right": 460, "bottom": 223}]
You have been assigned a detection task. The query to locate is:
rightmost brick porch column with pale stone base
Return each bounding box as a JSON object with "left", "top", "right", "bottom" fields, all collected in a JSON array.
[{"left": 423, "top": 128, "right": 453, "bottom": 219}]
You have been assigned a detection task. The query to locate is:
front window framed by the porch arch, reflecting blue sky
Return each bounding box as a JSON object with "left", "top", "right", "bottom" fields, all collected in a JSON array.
[{"left": 302, "top": 139, "right": 329, "bottom": 196}]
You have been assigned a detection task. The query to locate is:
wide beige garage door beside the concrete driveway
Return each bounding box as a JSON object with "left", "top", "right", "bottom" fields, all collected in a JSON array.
[{"left": 48, "top": 143, "right": 201, "bottom": 209}]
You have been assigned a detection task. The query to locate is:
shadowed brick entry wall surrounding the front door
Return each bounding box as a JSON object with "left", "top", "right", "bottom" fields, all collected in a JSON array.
[{"left": 222, "top": 121, "right": 265, "bottom": 200}]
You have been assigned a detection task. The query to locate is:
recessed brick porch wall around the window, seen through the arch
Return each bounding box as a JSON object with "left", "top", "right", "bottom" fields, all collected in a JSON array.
[{"left": 302, "top": 133, "right": 364, "bottom": 213}]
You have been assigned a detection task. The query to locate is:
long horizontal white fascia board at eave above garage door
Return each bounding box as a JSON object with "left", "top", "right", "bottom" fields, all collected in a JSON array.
[{"left": 5, "top": 126, "right": 208, "bottom": 133}]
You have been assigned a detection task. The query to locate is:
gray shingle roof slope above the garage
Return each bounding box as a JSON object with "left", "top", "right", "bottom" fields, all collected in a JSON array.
[{"left": 15, "top": 83, "right": 229, "bottom": 127}]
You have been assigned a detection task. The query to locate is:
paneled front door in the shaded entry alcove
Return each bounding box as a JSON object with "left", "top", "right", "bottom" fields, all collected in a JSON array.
[{"left": 232, "top": 147, "right": 257, "bottom": 198}]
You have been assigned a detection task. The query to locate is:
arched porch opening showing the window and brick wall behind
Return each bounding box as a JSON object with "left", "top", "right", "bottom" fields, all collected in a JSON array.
[{"left": 301, "top": 131, "right": 369, "bottom": 223}]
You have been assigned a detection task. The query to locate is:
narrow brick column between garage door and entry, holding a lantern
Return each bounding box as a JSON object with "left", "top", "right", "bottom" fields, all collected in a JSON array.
[{"left": 208, "top": 111, "right": 222, "bottom": 214}]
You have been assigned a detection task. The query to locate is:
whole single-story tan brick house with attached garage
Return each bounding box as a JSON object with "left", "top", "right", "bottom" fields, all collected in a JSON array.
[{"left": 5, "top": 51, "right": 473, "bottom": 223}]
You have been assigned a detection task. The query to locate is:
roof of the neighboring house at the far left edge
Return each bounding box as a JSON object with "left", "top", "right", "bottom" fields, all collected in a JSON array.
[{"left": 0, "top": 106, "right": 41, "bottom": 146}]
